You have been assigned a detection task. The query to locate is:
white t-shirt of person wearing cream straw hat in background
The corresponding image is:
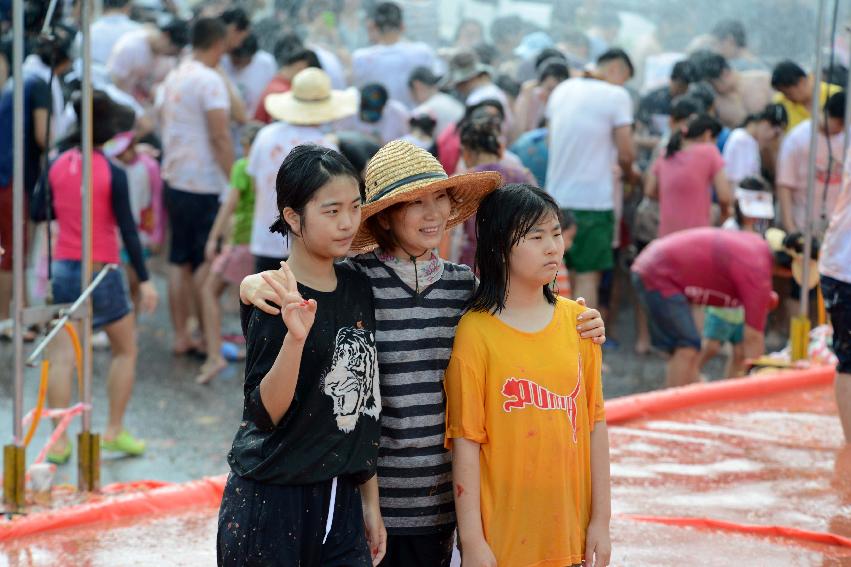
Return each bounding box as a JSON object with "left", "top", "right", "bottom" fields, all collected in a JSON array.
[{"left": 246, "top": 122, "right": 337, "bottom": 258}]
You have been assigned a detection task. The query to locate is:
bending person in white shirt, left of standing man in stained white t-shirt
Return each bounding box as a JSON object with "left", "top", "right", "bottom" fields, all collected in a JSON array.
[{"left": 106, "top": 20, "right": 189, "bottom": 104}]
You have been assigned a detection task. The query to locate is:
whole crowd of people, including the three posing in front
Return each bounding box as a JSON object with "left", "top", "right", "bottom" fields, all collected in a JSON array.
[{"left": 0, "top": 0, "right": 851, "bottom": 567}]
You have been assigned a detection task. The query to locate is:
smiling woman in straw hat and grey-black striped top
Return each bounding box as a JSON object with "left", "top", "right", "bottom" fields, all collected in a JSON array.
[{"left": 240, "top": 140, "right": 603, "bottom": 567}]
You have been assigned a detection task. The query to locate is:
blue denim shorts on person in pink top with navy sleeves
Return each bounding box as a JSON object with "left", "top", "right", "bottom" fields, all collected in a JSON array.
[{"left": 51, "top": 260, "right": 131, "bottom": 329}]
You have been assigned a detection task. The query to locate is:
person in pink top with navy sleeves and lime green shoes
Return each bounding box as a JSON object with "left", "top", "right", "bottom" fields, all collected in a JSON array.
[{"left": 47, "top": 91, "right": 157, "bottom": 464}]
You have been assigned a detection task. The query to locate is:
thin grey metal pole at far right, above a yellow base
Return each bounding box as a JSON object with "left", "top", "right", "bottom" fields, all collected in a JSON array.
[{"left": 800, "top": 0, "right": 830, "bottom": 320}]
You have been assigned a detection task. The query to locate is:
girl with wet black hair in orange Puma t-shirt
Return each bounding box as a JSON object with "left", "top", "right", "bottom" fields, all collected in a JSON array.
[{"left": 445, "top": 185, "right": 611, "bottom": 567}]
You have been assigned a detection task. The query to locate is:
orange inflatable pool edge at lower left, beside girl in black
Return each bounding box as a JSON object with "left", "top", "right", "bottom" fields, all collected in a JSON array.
[{"left": 0, "top": 475, "right": 227, "bottom": 541}]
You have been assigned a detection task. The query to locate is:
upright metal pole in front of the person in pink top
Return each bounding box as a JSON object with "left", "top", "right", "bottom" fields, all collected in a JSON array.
[{"left": 80, "top": 1, "right": 93, "bottom": 432}]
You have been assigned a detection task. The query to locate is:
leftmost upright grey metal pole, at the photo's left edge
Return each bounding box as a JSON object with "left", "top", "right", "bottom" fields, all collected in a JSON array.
[{"left": 10, "top": 0, "right": 25, "bottom": 445}]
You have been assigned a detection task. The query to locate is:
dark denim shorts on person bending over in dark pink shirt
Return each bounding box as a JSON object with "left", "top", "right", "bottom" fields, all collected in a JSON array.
[{"left": 632, "top": 272, "right": 701, "bottom": 353}]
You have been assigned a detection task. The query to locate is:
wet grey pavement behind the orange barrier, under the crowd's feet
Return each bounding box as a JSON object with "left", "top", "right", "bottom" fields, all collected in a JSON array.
[{"left": 0, "top": 268, "right": 723, "bottom": 484}]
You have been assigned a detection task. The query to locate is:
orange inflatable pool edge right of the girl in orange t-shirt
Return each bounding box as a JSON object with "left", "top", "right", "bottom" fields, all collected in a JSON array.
[{"left": 606, "top": 366, "right": 836, "bottom": 424}]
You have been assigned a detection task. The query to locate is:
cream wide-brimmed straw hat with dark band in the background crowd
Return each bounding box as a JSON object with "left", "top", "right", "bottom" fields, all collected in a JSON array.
[{"left": 265, "top": 67, "right": 358, "bottom": 126}]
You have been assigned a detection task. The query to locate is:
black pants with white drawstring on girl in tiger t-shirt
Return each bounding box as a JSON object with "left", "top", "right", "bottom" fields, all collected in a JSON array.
[{"left": 216, "top": 474, "right": 372, "bottom": 567}]
